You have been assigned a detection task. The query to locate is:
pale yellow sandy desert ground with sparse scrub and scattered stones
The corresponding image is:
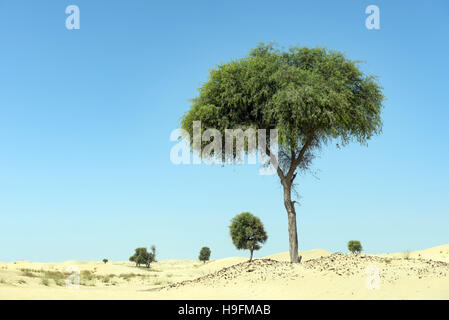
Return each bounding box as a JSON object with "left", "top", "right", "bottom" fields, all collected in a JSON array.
[{"left": 0, "top": 245, "right": 449, "bottom": 299}]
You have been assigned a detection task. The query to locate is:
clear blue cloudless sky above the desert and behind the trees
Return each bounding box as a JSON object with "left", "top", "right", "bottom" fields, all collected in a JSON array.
[{"left": 0, "top": 0, "right": 449, "bottom": 261}]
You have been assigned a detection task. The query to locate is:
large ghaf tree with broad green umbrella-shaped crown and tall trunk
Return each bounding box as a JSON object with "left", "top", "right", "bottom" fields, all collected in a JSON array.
[{"left": 181, "top": 44, "right": 384, "bottom": 262}]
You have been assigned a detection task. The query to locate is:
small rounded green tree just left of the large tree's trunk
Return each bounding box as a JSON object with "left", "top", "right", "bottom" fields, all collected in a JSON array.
[{"left": 229, "top": 212, "right": 268, "bottom": 261}]
